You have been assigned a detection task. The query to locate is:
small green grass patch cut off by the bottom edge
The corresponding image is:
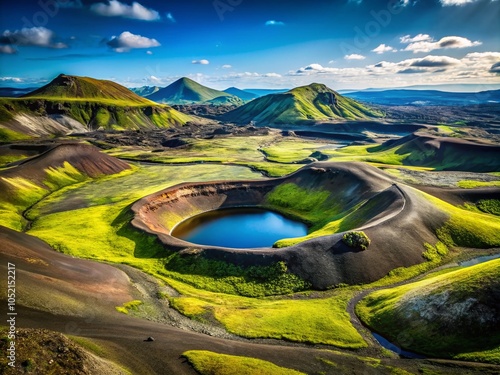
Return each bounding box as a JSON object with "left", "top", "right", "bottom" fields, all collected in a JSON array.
[{"left": 182, "top": 350, "right": 305, "bottom": 375}]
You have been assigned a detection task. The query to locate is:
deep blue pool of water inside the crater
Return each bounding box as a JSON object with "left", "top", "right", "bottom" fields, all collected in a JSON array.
[{"left": 172, "top": 207, "right": 307, "bottom": 249}]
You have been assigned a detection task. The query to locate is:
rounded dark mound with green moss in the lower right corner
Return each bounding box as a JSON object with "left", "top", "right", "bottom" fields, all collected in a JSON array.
[{"left": 357, "top": 260, "right": 500, "bottom": 364}]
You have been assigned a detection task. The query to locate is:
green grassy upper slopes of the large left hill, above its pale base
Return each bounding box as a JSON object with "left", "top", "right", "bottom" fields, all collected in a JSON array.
[{"left": 0, "top": 75, "right": 191, "bottom": 131}]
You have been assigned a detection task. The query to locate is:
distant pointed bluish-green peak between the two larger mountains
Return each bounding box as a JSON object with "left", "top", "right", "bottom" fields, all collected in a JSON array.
[{"left": 148, "top": 77, "right": 243, "bottom": 105}]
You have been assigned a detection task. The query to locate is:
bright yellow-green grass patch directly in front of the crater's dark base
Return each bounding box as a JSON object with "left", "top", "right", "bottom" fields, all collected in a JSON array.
[{"left": 169, "top": 280, "right": 367, "bottom": 349}]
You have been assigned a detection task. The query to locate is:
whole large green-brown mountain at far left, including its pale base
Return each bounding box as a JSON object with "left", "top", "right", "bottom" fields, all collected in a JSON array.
[{"left": 0, "top": 74, "right": 191, "bottom": 141}]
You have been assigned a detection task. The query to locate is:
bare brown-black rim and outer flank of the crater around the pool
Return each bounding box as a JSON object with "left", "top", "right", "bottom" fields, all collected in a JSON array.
[{"left": 132, "top": 163, "right": 447, "bottom": 289}]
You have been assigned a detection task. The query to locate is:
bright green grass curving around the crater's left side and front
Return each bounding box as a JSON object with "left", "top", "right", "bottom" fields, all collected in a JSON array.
[{"left": 4, "top": 165, "right": 366, "bottom": 348}]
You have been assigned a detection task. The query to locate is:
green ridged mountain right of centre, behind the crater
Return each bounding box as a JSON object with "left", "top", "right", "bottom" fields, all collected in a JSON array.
[{"left": 221, "top": 83, "right": 382, "bottom": 124}]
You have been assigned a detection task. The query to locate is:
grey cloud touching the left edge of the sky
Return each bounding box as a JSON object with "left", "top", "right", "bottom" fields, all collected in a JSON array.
[{"left": 0, "top": 27, "right": 68, "bottom": 48}]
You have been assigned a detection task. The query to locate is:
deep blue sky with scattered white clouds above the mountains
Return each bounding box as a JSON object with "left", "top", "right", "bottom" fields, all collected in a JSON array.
[{"left": 0, "top": 0, "right": 500, "bottom": 90}]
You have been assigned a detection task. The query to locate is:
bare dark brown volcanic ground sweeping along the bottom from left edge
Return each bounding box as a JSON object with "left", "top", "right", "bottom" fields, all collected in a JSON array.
[{"left": 0, "top": 227, "right": 498, "bottom": 375}]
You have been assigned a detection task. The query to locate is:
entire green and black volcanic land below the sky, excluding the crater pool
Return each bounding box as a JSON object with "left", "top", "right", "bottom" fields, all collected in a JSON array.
[{"left": 0, "top": 75, "right": 500, "bottom": 374}]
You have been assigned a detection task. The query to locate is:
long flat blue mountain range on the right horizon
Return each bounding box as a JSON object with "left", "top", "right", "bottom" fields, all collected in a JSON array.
[{"left": 344, "top": 89, "right": 500, "bottom": 106}]
